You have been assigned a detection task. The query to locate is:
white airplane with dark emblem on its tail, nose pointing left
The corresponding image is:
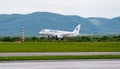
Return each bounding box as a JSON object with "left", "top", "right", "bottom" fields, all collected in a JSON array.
[{"left": 39, "top": 24, "right": 81, "bottom": 38}]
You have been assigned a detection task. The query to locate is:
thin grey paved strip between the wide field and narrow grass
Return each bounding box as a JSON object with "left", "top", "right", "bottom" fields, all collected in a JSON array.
[{"left": 0, "top": 52, "right": 120, "bottom": 56}]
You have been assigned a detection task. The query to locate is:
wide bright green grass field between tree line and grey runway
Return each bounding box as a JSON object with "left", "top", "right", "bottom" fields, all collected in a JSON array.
[{"left": 0, "top": 42, "right": 120, "bottom": 52}]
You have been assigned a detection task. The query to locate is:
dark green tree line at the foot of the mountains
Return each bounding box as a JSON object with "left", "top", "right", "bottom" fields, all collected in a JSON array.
[{"left": 0, "top": 35, "right": 120, "bottom": 42}]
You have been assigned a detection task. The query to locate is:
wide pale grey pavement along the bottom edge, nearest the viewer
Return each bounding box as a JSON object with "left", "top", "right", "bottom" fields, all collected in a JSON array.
[{"left": 0, "top": 59, "right": 120, "bottom": 69}]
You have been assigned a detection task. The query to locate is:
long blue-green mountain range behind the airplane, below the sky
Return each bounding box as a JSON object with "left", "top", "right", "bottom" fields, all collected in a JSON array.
[{"left": 0, "top": 12, "right": 120, "bottom": 36}]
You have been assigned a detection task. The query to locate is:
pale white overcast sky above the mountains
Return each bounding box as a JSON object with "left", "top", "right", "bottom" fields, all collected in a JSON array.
[{"left": 0, "top": 0, "right": 120, "bottom": 18}]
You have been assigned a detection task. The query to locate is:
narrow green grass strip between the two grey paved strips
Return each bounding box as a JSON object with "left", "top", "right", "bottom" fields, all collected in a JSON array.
[{"left": 0, "top": 55, "right": 120, "bottom": 61}]
